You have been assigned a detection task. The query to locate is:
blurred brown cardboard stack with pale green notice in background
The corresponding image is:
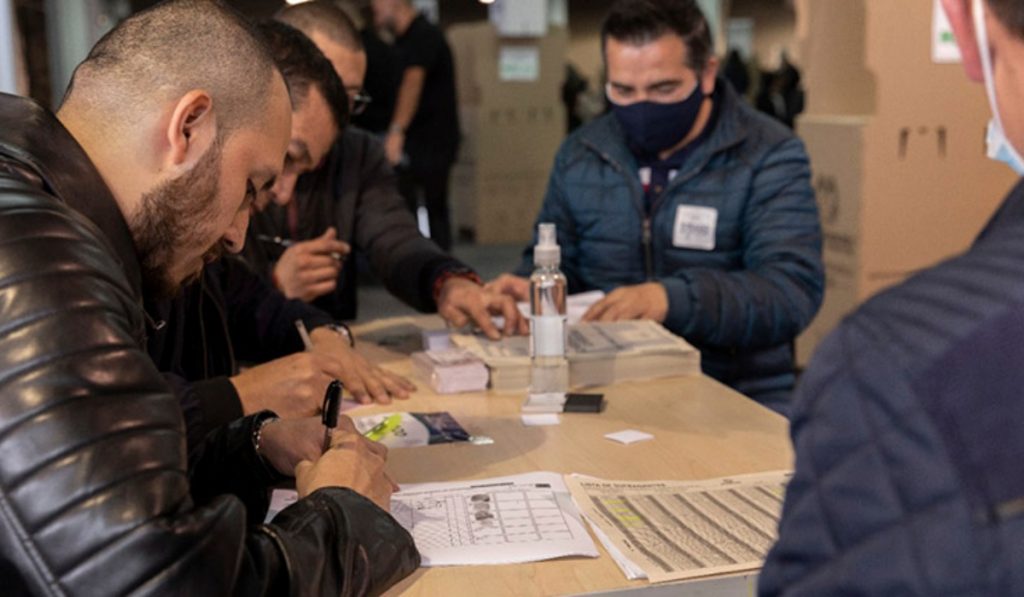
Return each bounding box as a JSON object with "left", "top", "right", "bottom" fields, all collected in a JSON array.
[{"left": 447, "top": 22, "right": 567, "bottom": 244}]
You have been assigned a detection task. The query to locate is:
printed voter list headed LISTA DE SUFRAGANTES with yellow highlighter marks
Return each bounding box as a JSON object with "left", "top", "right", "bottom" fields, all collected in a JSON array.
[{"left": 566, "top": 471, "right": 793, "bottom": 583}]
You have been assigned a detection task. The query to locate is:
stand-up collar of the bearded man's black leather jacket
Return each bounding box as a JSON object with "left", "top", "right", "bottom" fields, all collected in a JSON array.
[{"left": 0, "top": 93, "right": 142, "bottom": 298}]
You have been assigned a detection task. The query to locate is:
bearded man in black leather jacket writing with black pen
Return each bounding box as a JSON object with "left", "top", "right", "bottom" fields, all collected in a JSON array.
[{"left": 0, "top": 0, "right": 419, "bottom": 595}]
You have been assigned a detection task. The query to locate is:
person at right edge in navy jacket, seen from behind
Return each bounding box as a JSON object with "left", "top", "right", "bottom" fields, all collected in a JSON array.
[{"left": 759, "top": 0, "right": 1024, "bottom": 597}]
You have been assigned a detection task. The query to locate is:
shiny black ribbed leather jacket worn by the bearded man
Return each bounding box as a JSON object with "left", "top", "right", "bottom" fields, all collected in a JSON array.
[{"left": 0, "top": 94, "right": 419, "bottom": 596}]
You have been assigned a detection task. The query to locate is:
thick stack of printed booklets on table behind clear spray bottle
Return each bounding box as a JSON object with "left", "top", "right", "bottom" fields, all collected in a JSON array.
[{"left": 452, "top": 319, "right": 700, "bottom": 392}]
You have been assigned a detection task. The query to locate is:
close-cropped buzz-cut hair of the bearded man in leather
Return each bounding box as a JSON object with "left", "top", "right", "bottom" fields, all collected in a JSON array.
[{"left": 63, "top": 0, "right": 276, "bottom": 135}]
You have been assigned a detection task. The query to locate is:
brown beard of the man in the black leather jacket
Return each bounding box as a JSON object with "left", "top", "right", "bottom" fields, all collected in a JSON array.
[{"left": 128, "top": 135, "right": 223, "bottom": 299}]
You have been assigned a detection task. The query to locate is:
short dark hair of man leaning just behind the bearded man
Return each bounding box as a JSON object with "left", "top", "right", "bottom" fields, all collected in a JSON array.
[{"left": 259, "top": 20, "right": 348, "bottom": 131}]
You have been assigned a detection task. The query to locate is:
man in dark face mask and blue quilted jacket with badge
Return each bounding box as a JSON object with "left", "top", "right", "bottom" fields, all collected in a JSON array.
[{"left": 490, "top": 0, "right": 824, "bottom": 414}]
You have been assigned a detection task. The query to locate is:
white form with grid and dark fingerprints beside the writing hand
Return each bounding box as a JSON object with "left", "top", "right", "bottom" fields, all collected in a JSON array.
[{"left": 391, "top": 472, "right": 598, "bottom": 566}]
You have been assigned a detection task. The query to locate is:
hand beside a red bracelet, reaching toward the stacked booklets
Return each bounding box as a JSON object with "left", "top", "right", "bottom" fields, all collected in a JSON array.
[{"left": 437, "top": 278, "right": 529, "bottom": 340}]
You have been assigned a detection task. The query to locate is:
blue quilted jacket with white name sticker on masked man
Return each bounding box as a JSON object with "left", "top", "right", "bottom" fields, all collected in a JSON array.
[{"left": 517, "top": 80, "right": 824, "bottom": 412}]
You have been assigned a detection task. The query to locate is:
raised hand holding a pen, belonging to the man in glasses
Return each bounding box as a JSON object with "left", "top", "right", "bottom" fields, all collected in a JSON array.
[{"left": 273, "top": 227, "right": 351, "bottom": 302}]
